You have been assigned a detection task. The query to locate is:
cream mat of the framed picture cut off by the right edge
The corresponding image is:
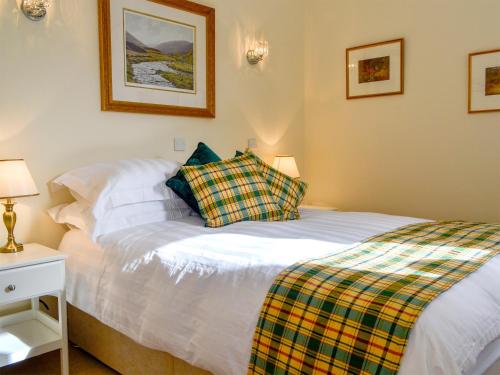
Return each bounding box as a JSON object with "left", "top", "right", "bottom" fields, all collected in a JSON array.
[{"left": 470, "top": 52, "right": 500, "bottom": 111}]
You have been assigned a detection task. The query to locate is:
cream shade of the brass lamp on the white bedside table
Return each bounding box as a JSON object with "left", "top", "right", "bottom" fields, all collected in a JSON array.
[{"left": 0, "top": 159, "right": 39, "bottom": 199}]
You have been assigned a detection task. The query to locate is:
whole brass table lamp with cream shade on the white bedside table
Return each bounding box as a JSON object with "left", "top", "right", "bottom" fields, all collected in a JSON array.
[{"left": 0, "top": 159, "right": 39, "bottom": 253}]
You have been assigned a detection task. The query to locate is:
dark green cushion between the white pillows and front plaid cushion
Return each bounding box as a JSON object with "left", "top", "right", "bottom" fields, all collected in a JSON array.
[{"left": 166, "top": 142, "right": 221, "bottom": 214}]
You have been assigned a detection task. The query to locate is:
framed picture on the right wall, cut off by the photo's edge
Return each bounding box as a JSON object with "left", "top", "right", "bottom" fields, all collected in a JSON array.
[{"left": 469, "top": 49, "right": 500, "bottom": 113}]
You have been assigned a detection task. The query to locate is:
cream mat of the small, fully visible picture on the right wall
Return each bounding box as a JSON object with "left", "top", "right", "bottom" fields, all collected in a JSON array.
[{"left": 347, "top": 41, "right": 401, "bottom": 96}]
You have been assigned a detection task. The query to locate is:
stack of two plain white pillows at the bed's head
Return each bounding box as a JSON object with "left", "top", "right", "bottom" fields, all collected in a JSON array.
[{"left": 49, "top": 159, "right": 191, "bottom": 240}]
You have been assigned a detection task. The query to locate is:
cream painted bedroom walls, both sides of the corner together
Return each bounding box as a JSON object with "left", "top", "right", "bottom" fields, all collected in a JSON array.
[{"left": 0, "top": 0, "right": 500, "bottom": 250}]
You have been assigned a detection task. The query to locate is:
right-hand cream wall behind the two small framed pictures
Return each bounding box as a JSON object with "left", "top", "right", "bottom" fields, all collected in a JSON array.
[{"left": 304, "top": 0, "right": 500, "bottom": 222}]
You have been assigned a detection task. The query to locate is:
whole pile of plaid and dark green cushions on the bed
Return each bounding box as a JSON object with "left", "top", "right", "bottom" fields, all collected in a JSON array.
[{"left": 167, "top": 143, "right": 307, "bottom": 228}]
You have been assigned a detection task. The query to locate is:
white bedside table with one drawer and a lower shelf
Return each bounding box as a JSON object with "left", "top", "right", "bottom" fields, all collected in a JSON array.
[{"left": 0, "top": 244, "right": 69, "bottom": 375}]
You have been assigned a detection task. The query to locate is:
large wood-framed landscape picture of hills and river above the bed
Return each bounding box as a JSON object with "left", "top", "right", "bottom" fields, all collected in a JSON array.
[{"left": 98, "top": 0, "right": 215, "bottom": 117}]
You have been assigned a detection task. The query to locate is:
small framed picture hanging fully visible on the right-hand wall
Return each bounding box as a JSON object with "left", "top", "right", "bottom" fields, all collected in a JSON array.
[{"left": 346, "top": 39, "right": 404, "bottom": 99}]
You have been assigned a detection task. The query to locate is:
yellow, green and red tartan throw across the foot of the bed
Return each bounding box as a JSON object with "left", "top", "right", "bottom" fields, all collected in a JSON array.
[{"left": 248, "top": 222, "right": 500, "bottom": 374}]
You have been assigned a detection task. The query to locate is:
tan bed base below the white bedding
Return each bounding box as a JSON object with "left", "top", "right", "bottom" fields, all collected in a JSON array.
[{"left": 68, "top": 304, "right": 210, "bottom": 375}]
